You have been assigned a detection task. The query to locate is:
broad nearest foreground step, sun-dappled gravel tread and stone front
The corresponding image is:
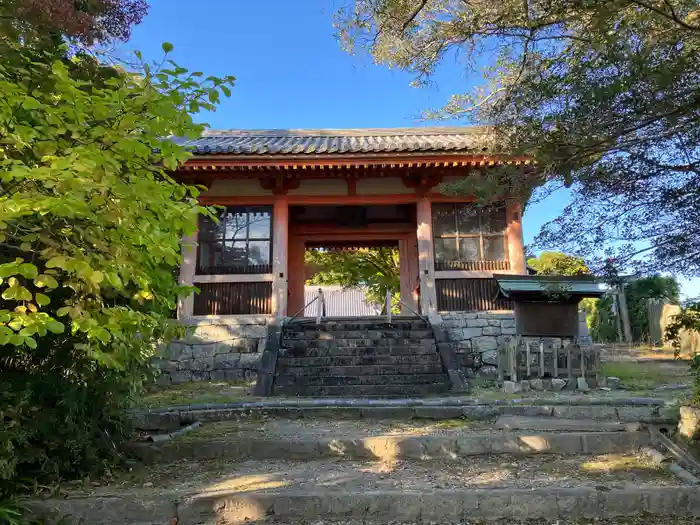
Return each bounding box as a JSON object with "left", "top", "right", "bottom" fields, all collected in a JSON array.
[{"left": 34, "top": 450, "right": 700, "bottom": 525}]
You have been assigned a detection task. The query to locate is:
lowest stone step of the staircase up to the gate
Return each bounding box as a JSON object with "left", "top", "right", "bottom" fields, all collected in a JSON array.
[{"left": 274, "top": 376, "right": 450, "bottom": 398}]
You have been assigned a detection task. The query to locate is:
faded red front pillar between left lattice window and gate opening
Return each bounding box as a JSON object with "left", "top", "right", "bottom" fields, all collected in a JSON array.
[{"left": 272, "top": 196, "right": 289, "bottom": 317}]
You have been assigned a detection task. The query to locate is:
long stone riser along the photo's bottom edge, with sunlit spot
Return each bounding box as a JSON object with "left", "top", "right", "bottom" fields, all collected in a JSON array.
[{"left": 30, "top": 486, "right": 700, "bottom": 525}]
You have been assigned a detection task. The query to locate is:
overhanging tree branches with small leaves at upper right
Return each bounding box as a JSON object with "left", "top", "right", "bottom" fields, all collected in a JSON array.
[{"left": 336, "top": 0, "right": 700, "bottom": 275}]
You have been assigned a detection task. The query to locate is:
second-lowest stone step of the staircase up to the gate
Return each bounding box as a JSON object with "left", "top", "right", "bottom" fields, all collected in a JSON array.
[{"left": 275, "top": 367, "right": 445, "bottom": 387}]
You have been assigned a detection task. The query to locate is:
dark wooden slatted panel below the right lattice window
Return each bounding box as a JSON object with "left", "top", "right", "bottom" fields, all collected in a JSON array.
[{"left": 435, "top": 279, "right": 513, "bottom": 312}]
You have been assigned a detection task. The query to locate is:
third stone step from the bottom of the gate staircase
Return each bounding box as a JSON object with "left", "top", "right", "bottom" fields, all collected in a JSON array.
[{"left": 277, "top": 354, "right": 440, "bottom": 370}]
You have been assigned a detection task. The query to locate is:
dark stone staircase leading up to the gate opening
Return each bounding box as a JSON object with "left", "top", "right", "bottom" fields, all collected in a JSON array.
[{"left": 273, "top": 317, "right": 450, "bottom": 397}]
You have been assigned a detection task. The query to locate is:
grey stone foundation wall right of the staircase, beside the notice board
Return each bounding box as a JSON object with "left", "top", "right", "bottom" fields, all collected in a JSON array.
[{"left": 440, "top": 311, "right": 515, "bottom": 374}]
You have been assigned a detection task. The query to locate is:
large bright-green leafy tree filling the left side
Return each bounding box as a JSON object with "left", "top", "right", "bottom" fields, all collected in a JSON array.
[{"left": 0, "top": 38, "right": 233, "bottom": 499}]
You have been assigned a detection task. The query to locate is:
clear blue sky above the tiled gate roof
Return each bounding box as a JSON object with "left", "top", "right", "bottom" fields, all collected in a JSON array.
[{"left": 119, "top": 0, "right": 700, "bottom": 296}]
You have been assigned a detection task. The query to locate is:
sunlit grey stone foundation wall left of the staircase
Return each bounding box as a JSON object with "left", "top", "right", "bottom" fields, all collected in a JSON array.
[{"left": 155, "top": 316, "right": 272, "bottom": 384}]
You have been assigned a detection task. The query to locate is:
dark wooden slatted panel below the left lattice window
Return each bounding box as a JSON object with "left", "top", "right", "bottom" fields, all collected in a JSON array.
[{"left": 194, "top": 282, "right": 272, "bottom": 315}]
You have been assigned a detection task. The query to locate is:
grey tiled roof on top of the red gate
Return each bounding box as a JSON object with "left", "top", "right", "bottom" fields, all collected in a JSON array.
[{"left": 175, "top": 126, "right": 489, "bottom": 155}]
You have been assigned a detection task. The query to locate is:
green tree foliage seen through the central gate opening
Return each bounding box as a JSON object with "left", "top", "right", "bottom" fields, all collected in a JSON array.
[{"left": 305, "top": 248, "right": 401, "bottom": 313}]
